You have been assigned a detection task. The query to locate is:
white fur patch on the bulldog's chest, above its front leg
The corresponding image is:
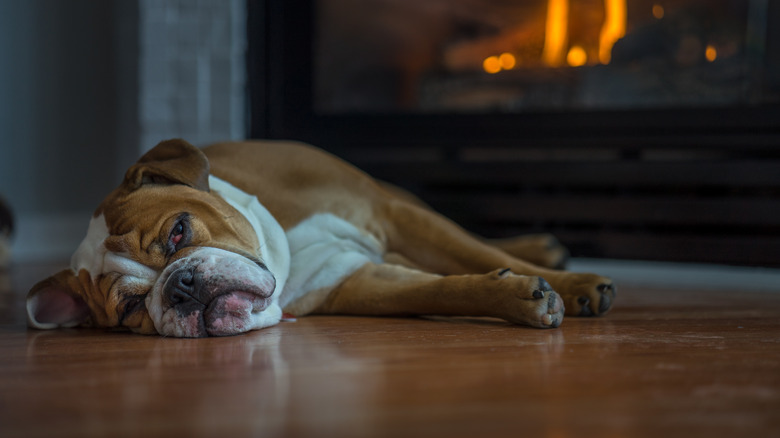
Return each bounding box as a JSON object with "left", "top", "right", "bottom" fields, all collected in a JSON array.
[{"left": 279, "top": 213, "right": 384, "bottom": 314}]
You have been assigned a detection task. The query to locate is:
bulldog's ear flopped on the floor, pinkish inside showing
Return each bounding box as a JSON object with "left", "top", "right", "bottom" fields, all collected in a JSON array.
[{"left": 27, "top": 269, "right": 89, "bottom": 329}]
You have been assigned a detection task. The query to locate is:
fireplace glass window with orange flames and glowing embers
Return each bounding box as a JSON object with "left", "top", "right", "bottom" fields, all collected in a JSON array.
[{"left": 313, "top": 0, "right": 780, "bottom": 113}]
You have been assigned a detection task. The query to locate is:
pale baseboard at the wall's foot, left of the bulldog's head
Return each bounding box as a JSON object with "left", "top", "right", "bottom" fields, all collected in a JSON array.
[{"left": 11, "top": 212, "right": 92, "bottom": 262}]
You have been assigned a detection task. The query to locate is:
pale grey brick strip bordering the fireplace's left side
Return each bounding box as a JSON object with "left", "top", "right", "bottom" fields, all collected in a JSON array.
[{"left": 138, "top": 0, "right": 246, "bottom": 152}]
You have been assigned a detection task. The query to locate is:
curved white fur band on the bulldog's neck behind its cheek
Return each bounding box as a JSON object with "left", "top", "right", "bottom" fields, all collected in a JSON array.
[{"left": 209, "top": 175, "right": 290, "bottom": 299}]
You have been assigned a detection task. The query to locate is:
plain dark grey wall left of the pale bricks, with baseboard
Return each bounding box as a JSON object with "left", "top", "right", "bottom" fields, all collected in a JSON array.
[{"left": 0, "top": 0, "right": 137, "bottom": 260}]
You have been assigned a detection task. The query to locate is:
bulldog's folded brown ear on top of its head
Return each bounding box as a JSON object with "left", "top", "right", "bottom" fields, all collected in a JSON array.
[{"left": 124, "top": 139, "right": 209, "bottom": 192}]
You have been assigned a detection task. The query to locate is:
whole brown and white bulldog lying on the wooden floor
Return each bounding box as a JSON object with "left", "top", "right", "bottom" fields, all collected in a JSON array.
[{"left": 27, "top": 140, "right": 615, "bottom": 337}]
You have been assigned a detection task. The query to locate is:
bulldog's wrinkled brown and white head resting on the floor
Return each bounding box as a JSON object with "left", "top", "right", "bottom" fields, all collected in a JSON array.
[{"left": 27, "top": 140, "right": 281, "bottom": 337}]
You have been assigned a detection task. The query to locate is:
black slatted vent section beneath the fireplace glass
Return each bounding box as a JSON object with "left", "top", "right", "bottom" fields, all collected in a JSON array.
[{"left": 350, "top": 144, "right": 780, "bottom": 266}]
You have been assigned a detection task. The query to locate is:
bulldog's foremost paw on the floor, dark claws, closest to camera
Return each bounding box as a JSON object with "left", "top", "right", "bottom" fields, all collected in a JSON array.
[{"left": 494, "top": 269, "right": 565, "bottom": 328}]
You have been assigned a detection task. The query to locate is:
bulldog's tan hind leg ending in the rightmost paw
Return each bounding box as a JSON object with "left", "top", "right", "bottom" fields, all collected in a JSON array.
[{"left": 386, "top": 201, "right": 616, "bottom": 316}]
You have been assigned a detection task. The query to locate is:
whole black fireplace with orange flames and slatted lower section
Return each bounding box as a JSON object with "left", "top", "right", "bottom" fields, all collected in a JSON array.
[{"left": 248, "top": 0, "right": 780, "bottom": 266}]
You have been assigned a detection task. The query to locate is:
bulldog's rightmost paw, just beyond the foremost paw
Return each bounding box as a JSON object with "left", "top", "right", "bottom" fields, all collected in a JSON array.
[{"left": 556, "top": 273, "right": 617, "bottom": 316}]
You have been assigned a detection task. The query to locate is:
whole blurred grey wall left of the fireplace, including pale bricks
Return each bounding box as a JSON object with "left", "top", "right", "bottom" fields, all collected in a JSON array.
[{"left": 0, "top": 0, "right": 245, "bottom": 261}]
